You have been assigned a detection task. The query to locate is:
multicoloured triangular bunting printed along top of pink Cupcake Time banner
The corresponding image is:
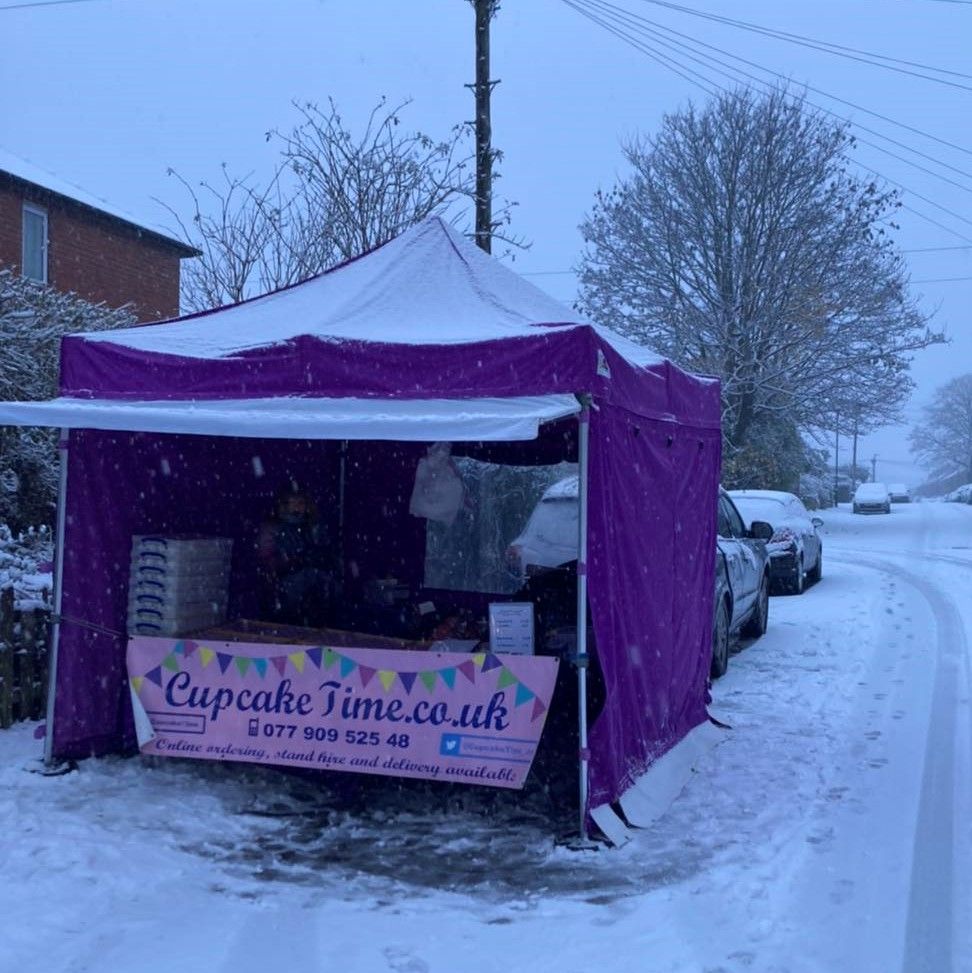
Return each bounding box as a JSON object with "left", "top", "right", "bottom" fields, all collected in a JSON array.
[{"left": 131, "top": 639, "right": 547, "bottom": 720}]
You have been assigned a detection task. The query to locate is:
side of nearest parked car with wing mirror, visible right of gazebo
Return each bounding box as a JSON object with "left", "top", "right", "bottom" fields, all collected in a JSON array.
[{"left": 710, "top": 489, "right": 773, "bottom": 679}]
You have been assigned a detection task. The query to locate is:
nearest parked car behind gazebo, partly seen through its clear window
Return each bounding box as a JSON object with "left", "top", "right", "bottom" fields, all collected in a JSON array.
[{"left": 506, "top": 476, "right": 773, "bottom": 678}]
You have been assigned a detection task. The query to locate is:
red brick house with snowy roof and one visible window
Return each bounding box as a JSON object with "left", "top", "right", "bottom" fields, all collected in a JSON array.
[{"left": 0, "top": 150, "right": 198, "bottom": 321}]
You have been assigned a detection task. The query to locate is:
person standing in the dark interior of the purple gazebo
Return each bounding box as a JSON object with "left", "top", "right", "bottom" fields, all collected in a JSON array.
[{"left": 257, "top": 485, "right": 336, "bottom": 627}]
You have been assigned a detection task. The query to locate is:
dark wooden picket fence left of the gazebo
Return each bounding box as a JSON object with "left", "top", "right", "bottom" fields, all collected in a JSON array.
[{"left": 0, "top": 588, "right": 51, "bottom": 729}]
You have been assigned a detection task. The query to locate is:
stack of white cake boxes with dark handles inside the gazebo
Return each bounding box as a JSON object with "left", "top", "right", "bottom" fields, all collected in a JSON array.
[{"left": 128, "top": 534, "right": 233, "bottom": 636}]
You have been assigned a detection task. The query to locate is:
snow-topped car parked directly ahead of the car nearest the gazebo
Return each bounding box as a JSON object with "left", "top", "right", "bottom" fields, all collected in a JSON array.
[{"left": 729, "top": 490, "right": 823, "bottom": 595}]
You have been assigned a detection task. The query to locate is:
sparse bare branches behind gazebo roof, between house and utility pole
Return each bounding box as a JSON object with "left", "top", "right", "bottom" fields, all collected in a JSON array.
[{"left": 163, "top": 99, "right": 519, "bottom": 310}]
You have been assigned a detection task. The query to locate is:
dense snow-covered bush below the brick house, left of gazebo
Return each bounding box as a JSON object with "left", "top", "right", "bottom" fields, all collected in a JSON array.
[{"left": 0, "top": 268, "right": 136, "bottom": 530}]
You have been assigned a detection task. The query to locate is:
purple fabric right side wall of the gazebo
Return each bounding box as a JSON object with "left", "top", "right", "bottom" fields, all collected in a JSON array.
[{"left": 589, "top": 409, "right": 720, "bottom": 806}]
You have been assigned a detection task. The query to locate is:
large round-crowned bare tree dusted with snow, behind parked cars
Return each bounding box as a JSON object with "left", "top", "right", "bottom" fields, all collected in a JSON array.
[{"left": 579, "top": 89, "right": 943, "bottom": 472}]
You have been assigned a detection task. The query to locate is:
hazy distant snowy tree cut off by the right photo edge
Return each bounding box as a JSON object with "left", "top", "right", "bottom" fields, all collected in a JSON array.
[{"left": 910, "top": 374, "right": 972, "bottom": 483}]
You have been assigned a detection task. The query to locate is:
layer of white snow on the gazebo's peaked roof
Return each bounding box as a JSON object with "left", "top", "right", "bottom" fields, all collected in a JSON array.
[{"left": 76, "top": 217, "right": 663, "bottom": 366}]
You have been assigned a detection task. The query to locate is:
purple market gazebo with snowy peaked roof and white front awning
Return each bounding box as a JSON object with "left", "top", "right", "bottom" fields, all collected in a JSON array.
[{"left": 0, "top": 218, "right": 720, "bottom": 831}]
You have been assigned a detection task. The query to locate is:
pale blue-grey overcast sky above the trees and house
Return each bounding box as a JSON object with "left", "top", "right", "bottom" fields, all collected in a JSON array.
[{"left": 0, "top": 0, "right": 972, "bottom": 482}]
